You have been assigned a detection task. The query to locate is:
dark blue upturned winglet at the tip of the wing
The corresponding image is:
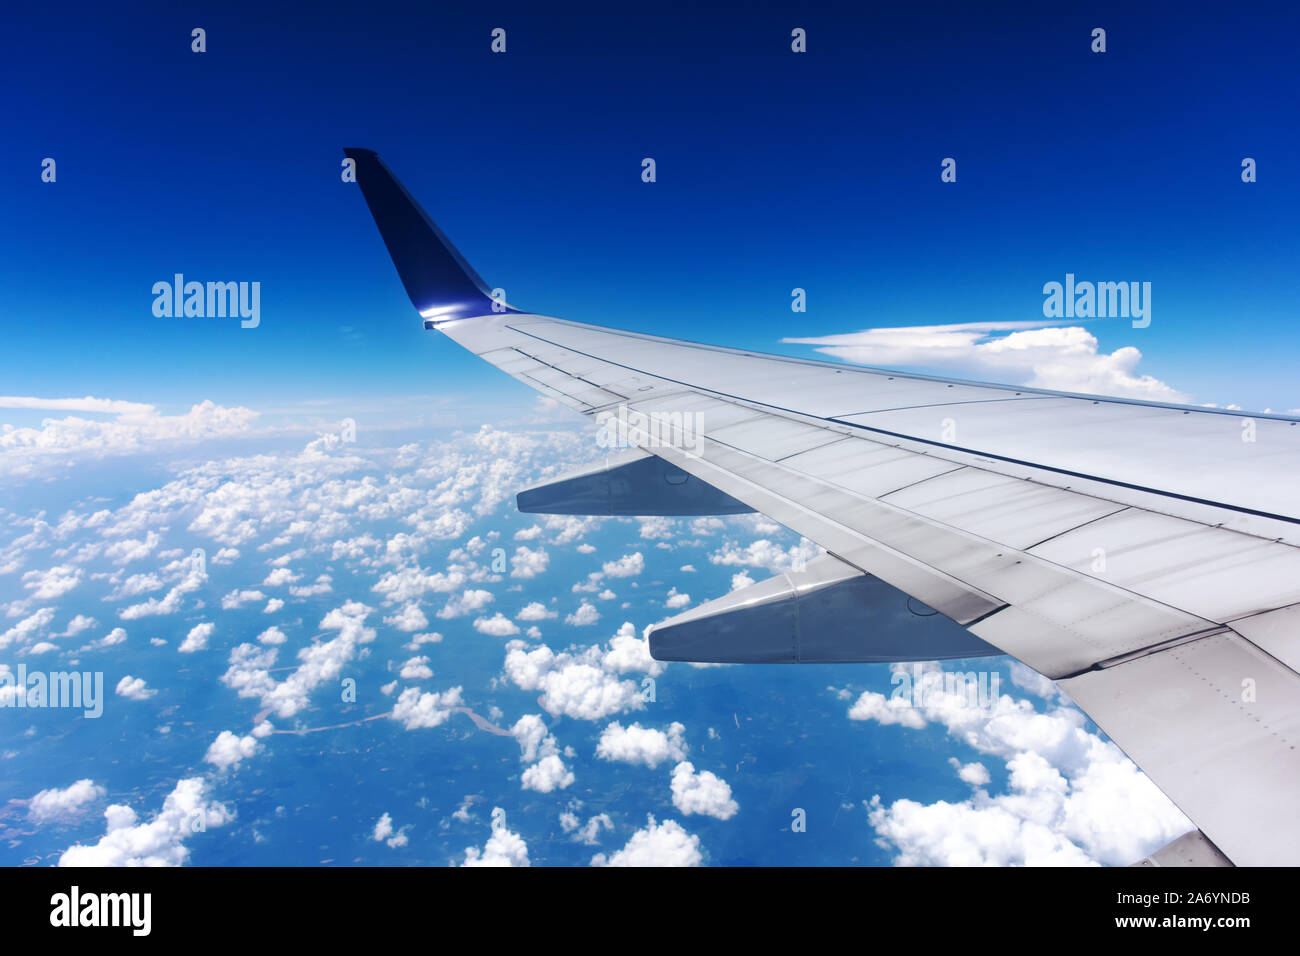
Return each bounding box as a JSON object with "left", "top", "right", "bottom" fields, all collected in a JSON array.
[{"left": 343, "top": 150, "right": 519, "bottom": 319}]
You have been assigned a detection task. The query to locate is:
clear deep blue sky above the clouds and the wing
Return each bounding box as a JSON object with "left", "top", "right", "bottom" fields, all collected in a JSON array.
[{"left": 0, "top": 3, "right": 1300, "bottom": 420}]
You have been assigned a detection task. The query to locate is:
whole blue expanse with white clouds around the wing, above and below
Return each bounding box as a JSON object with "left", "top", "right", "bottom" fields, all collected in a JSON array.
[{"left": 10, "top": 3, "right": 1284, "bottom": 864}]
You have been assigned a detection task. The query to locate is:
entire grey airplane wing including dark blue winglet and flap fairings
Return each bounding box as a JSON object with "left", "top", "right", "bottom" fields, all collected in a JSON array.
[{"left": 345, "top": 150, "right": 1300, "bottom": 865}]
